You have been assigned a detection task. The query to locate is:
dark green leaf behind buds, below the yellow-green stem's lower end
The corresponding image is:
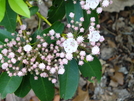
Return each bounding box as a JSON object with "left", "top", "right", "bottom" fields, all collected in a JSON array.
[{"left": 41, "top": 21, "right": 64, "bottom": 44}]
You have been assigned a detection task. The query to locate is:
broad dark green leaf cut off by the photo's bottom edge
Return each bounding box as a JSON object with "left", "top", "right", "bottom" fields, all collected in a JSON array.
[{"left": 30, "top": 75, "right": 54, "bottom": 101}]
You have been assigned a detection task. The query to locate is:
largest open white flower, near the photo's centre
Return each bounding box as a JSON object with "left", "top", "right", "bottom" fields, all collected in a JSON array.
[{"left": 63, "top": 38, "right": 78, "bottom": 53}]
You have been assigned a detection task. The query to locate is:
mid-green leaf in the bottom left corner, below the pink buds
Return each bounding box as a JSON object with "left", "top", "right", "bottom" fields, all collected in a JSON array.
[{"left": 0, "top": 72, "right": 22, "bottom": 99}]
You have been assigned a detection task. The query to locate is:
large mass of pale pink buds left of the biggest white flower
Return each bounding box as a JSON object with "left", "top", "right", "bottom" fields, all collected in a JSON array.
[{"left": 0, "top": 25, "right": 68, "bottom": 83}]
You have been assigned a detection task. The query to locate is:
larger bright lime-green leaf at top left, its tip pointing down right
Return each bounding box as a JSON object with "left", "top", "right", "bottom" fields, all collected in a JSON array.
[{"left": 8, "top": 0, "right": 30, "bottom": 18}]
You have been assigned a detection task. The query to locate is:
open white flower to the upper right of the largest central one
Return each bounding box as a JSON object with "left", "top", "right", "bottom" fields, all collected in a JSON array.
[{"left": 88, "top": 31, "right": 100, "bottom": 42}]
